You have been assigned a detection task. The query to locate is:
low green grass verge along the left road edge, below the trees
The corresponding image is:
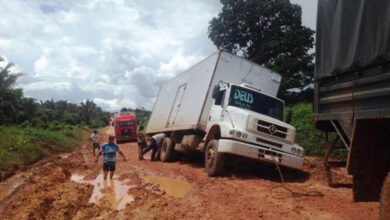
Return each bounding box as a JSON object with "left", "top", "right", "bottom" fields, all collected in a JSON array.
[{"left": 0, "top": 123, "right": 85, "bottom": 180}]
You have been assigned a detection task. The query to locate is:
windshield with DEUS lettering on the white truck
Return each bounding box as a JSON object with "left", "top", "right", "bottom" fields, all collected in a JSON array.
[{"left": 229, "top": 86, "right": 283, "bottom": 121}]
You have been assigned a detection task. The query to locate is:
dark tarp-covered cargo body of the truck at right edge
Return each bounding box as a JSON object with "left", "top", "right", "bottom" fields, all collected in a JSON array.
[{"left": 314, "top": 0, "right": 390, "bottom": 138}]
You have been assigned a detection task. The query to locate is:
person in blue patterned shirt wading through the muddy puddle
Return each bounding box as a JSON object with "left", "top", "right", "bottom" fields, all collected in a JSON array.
[{"left": 95, "top": 135, "right": 126, "bottom": 180}]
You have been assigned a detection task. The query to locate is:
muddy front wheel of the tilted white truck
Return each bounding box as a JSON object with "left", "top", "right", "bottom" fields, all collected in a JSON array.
[{"left": 204, "top": 140, "right": 224, "bottom": 176}]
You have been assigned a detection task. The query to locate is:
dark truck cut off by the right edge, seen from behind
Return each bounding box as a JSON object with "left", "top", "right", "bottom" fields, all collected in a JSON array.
[{"left": 314, "top": 0, "right": 390, "bottom": 219}]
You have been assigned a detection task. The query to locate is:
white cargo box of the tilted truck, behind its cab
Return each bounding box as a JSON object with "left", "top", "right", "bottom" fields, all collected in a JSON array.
[{"left": 146, "top": 51, "right": 281, "bottom": 134}]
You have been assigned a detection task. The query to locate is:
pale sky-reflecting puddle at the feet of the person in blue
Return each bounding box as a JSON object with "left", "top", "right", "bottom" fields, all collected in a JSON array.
[{"left": 72, "top": 174, "right": 134, "bottom": 210}]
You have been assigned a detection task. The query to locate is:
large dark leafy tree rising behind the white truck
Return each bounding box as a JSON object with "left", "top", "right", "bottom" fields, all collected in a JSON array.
[{"left": 209, "top": 0, "right": 314, "bottom": 103}]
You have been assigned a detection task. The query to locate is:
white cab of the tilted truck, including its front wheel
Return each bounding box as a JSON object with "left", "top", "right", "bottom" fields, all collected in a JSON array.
[{"left": 204, "top": 83, "right": 303, "bottom": 175}]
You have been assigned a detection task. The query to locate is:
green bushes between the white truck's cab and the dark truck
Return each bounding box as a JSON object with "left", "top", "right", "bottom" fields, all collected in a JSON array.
[{"left": 286, "top": 103, "right": 347, "bottom": 159}]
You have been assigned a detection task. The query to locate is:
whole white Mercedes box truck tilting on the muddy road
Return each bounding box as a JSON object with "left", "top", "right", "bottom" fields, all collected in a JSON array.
[{"left": 146, "top": 51, "right": 303, "bottom": 176}]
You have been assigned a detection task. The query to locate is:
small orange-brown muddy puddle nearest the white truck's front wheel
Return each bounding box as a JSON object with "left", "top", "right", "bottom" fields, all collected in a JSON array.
[{"left": 143, "top": 176, "right": 192, "bottom": 198}]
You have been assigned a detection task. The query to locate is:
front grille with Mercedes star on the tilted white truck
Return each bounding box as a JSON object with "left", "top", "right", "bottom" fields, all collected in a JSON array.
[{"left": 248, "top": 117, "right": 288, "bottom": 139}]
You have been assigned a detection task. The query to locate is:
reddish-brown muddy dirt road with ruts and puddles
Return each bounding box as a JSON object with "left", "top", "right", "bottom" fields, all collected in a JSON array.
[{"left": 0, "top": 126, "right": 378, "bottom": 219}]
